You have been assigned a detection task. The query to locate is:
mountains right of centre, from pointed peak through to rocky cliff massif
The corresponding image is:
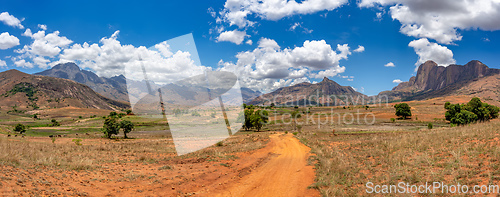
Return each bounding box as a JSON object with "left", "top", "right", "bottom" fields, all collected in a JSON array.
[{"left": 249, "top": 60, "right": 500, "bottom": 105}]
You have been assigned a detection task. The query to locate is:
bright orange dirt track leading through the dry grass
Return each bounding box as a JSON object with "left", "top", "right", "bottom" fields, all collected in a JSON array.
[{"left": 209, "top": 134, "right": 319, "bottom": 196}]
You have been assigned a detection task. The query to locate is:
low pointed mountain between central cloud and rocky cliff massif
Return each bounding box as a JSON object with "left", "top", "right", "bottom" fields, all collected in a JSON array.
[{"left": 248, "top": 77, "right": 368, "bottom": 105}]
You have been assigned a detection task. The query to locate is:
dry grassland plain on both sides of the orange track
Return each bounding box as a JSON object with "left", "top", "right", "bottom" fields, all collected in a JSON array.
[{"left": 0, "top": 94, "right": 500, "bottom": 196}]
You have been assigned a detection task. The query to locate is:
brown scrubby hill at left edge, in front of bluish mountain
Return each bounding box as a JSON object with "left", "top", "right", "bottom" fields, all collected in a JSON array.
[{"left": 0, "top": 70, "right": 130, "bottom": 110}]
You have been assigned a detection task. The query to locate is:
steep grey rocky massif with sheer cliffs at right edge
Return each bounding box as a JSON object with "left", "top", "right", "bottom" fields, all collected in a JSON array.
[{"left": 379, "top": 60, "right": 500, "bottom": 101}]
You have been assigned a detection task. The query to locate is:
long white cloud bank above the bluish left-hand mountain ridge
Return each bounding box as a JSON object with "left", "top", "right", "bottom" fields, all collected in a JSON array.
[{"left": 59, "top": 31, "right": 209, "bottom": 84}]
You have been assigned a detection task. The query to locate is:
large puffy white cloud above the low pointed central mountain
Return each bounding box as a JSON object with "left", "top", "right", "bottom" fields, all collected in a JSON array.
[{"left": 219, "top": 38, "right": 351, "bottom": 92}]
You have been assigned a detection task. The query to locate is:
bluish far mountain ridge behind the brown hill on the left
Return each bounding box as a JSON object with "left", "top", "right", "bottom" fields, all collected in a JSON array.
[{"left": 35, "top": 62, "right": 129, "bottom": 102}]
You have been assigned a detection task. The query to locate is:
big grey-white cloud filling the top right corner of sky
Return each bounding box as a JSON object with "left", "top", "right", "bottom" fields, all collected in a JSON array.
[{"left": 358, "top": 0, "right": 500, "bottom": 44}]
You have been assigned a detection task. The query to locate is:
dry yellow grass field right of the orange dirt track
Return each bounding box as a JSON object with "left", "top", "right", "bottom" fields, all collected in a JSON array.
[{"left": 298, "top": 121, "right": 500, "bottom": 196}]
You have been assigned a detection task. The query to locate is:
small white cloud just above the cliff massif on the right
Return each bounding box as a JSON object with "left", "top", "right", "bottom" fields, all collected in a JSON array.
[{"left": 408, "top": 38, "right": 456, "bottom": 70}]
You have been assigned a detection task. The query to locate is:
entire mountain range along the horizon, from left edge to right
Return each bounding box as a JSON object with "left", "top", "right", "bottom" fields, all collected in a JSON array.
[{"left": 0, "top": 60, "right": 500, "bottom": 109}]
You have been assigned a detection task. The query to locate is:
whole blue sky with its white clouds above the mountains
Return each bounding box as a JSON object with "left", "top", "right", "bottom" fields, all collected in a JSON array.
[{"left": 0, "top": 0, "right": 500, "bottom": 95}]
